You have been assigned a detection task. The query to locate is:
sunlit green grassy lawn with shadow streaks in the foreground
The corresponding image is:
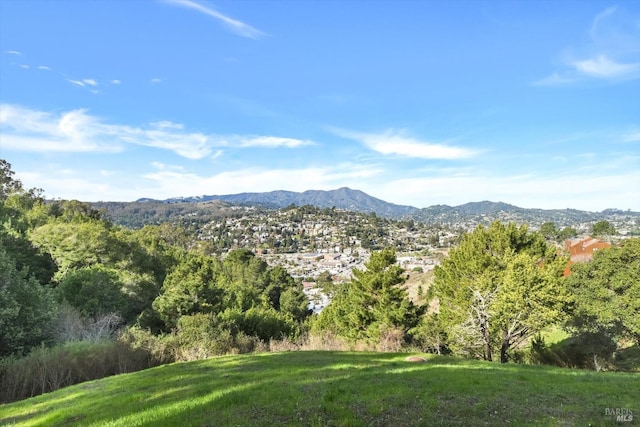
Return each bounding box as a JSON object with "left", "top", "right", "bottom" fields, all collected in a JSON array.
[{"left": 0, "top": 352, "right": 640, "bottom": 427}]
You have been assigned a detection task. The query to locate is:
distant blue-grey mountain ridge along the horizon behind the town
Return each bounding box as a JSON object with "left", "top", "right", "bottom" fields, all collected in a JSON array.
[{"left": 92, "top": 187, "right": 640, "bottom": 231}]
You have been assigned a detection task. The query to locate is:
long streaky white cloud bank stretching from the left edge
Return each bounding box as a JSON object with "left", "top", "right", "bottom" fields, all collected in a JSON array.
[{"left": 0, "top": 104, "right": 312, "bottom": 159}]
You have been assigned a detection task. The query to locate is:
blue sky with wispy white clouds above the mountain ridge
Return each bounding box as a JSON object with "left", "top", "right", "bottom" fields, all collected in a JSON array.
[{"left": 0, "top": 0, "right": 640, "bottom": 211}]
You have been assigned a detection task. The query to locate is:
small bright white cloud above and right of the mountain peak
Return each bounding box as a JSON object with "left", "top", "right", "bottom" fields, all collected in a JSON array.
[{"left": 334, "top": 130, "right": 478, "bottom": 160}]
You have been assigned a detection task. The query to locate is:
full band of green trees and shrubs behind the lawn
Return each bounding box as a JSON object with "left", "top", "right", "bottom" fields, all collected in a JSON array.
[{"left": 0, "top": 160, "right": 640, "bottom": 402}]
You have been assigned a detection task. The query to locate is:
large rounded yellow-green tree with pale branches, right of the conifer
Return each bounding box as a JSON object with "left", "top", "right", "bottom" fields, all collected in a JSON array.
[{"left": 433, "top": 222, "right": 568, "bottom": 362}]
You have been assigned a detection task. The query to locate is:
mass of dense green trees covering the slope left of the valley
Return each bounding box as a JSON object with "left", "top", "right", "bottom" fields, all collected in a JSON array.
[{"left": 0, "top": 160, "right": 310, "bottom": 388}]
